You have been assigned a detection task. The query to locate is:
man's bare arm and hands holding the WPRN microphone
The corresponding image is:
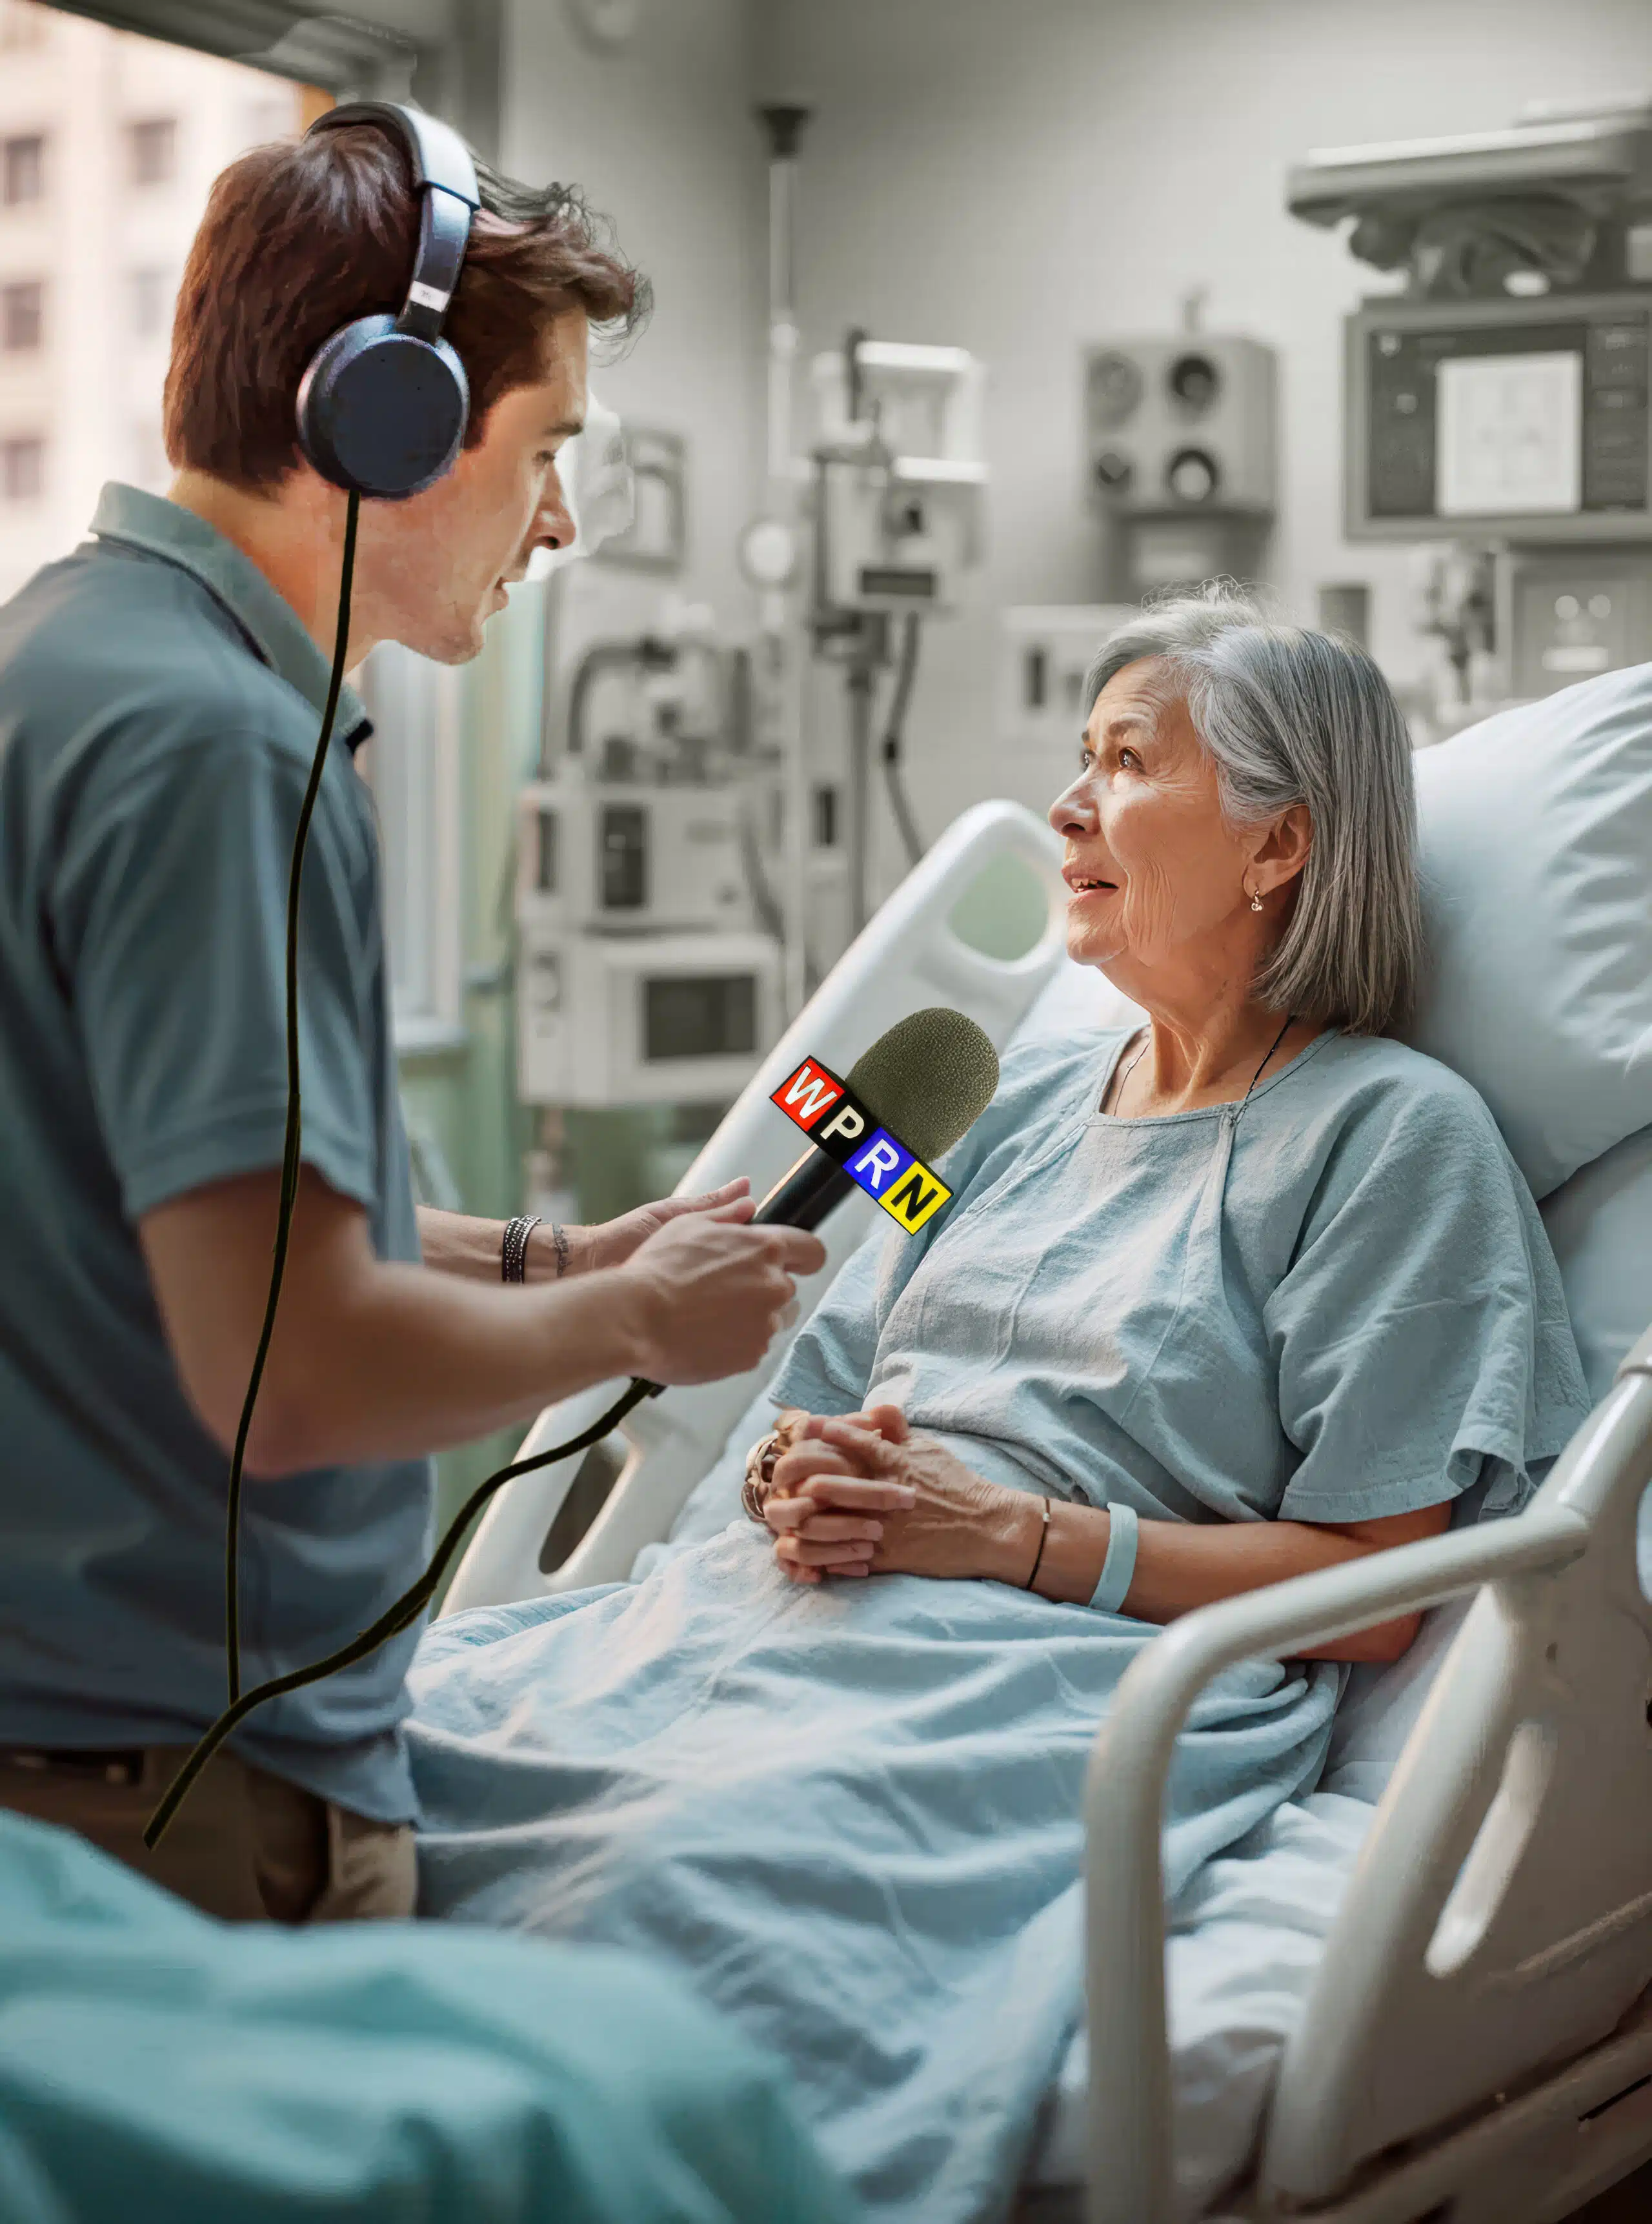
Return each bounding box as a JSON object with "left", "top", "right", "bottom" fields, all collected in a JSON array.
[{"left": 140, "top": 1168, "right": 825, "bottom": 1477}]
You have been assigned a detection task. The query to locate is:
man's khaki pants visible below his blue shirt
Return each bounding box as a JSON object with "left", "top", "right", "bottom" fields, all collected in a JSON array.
[{"left": 0, "top": 1746, "right": 418, "bottom": 1924}]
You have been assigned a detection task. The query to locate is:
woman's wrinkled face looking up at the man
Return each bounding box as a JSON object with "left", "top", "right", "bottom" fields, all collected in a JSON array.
[{"left": 1049, "top": 658, "right": 1256, "bottom": 992}]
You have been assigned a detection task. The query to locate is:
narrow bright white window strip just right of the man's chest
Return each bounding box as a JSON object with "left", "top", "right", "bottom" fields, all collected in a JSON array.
[{"left": 360, "top": 643, "right": 465, "bottom": 1050}]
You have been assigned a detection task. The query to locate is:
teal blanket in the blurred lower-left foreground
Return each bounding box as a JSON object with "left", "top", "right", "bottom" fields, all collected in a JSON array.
[{"left": 0, "top": 1810, "right": 852, "bottom": 2224}]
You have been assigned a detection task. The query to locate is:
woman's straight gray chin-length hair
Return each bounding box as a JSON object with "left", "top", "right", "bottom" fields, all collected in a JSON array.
[{"left": 1085, "top": 580, "right": 1423, "bottom": 1034}]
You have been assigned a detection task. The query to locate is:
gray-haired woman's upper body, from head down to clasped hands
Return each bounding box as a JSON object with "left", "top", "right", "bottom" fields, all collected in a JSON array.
[{"left": 747, "top": 598, "right": 1586, "bottom": 1659}]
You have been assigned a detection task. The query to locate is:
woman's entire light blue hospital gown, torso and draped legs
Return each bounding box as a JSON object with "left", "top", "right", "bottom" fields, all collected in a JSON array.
[{"left": 409, "top": 1034, "right": 1586, "bottom": 2224}]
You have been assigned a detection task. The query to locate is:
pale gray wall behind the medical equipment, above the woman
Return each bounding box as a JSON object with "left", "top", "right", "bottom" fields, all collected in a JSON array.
[{"left": 758, "top": 0, "right": 1652, "bottom": 885}]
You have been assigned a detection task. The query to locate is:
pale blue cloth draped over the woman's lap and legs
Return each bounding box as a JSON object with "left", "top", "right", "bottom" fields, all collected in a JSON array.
[{"left": 409, "top": 1524, "right": 1341, "bottom": 2224}]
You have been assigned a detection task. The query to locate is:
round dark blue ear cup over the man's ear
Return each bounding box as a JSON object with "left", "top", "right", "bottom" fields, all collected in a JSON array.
[{"left": 298, "top": 316, "right": 471, "bottom": 503}]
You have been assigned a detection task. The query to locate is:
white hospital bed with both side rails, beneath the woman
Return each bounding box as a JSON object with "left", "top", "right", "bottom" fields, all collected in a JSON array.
[{"left": 443, "top": 803, "right": 1652, "bottom": 2224}]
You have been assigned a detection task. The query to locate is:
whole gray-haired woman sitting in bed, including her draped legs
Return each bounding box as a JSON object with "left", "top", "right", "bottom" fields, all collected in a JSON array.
[{"left": 409, "top": 596, "right": 1587, "bottom": 2224}]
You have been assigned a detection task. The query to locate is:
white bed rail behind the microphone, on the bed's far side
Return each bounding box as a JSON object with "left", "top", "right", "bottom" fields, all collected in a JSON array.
[{"left": 443, "top": 803, "right": 1067, "bottom": 1615}]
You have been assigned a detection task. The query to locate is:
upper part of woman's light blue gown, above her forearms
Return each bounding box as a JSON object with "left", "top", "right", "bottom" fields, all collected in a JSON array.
[{"left": 772, "top": 1032, "right": 1587, "bottom": 1521}]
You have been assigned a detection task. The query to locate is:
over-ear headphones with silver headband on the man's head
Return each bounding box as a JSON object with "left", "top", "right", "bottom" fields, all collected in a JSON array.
[{"left": 298, "top": 100, "right": 480, "bottom": 503}]
